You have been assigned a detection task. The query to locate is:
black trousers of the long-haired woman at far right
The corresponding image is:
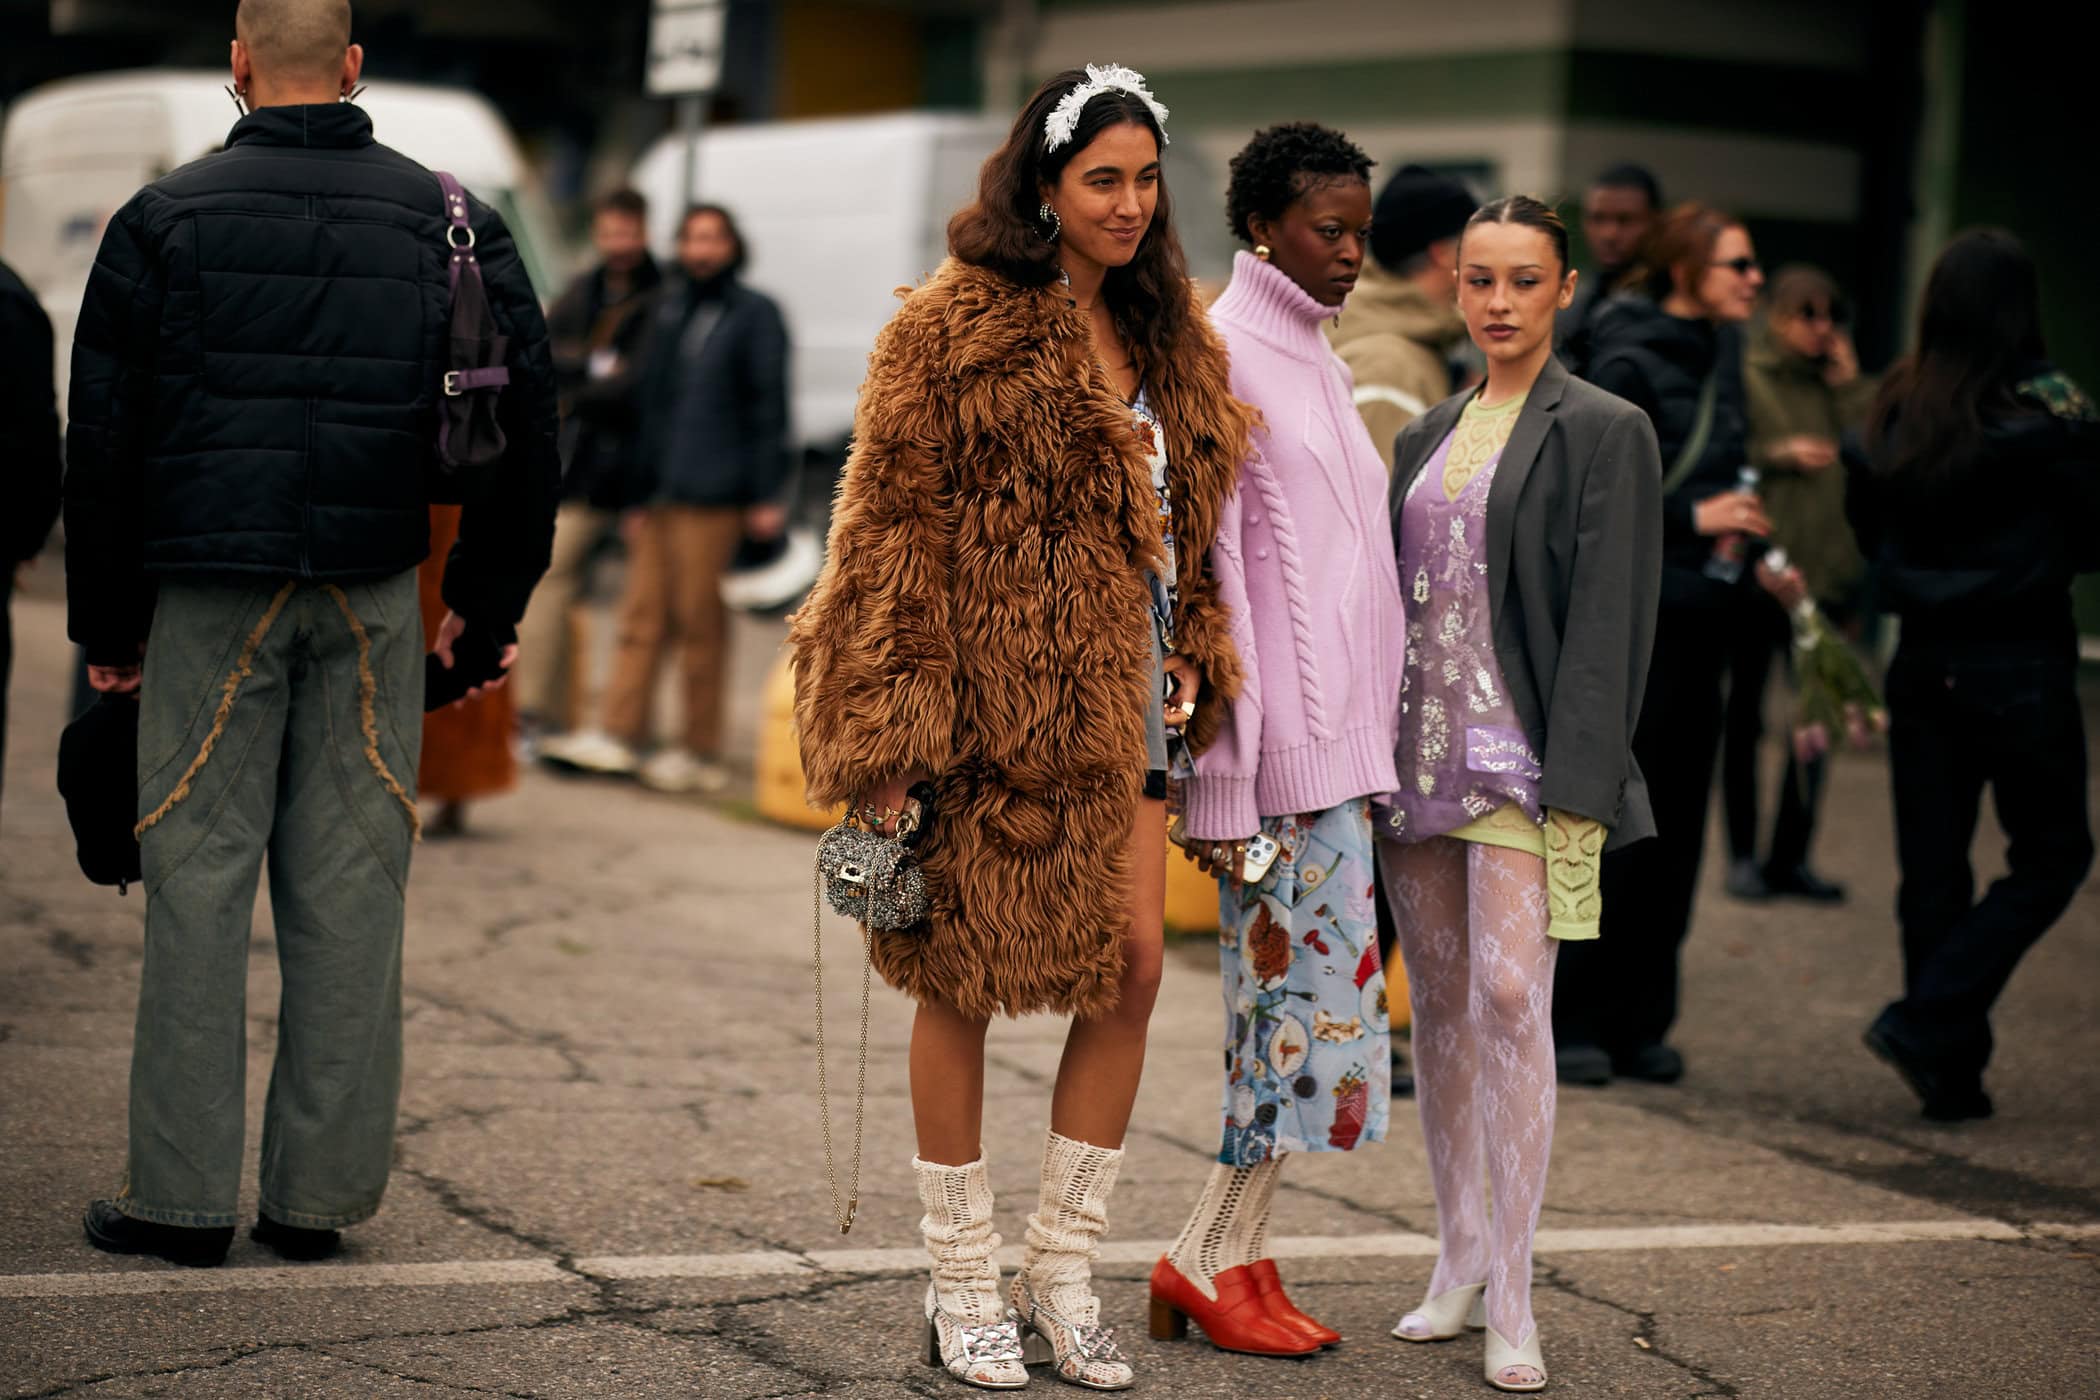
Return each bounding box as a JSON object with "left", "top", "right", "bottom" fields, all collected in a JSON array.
[{"left": 1888, "top": 646, "right": 2094, "bottom": 1073}]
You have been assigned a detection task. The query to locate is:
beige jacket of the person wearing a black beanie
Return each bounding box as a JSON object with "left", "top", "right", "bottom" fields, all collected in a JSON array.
[{"left": 1327, "top": 258, "right": 1466, "bottom": 470}]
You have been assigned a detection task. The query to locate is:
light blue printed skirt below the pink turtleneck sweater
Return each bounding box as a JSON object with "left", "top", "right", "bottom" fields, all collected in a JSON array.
[{"left": 1218, "top": 798, "right": 1392, "bottom": 1167}]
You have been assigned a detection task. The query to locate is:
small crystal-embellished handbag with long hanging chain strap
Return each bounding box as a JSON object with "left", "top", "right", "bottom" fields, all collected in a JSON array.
[{"left": 811, "top": 783, "right": 932, "bottom": 1234}]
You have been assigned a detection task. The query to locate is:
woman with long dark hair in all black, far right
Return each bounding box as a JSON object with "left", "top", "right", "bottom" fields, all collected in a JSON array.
[{"left": 1846, "top": 229, "right": 2100, "bottom": 1121}]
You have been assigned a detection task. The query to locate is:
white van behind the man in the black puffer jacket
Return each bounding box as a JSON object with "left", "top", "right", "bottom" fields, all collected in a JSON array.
[{"left": 0, "top": 69, "right": 565, "bottom": 409}]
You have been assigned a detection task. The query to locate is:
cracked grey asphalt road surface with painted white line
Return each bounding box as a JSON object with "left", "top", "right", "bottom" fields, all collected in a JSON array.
[{"left": 0, "top": 596, "right": 2100, "bottom": 1400}]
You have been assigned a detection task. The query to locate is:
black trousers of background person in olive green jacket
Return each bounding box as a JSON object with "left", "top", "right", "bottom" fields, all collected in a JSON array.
[{"left": 1720, "top": 590, "right": 1825, "bottom": 875}]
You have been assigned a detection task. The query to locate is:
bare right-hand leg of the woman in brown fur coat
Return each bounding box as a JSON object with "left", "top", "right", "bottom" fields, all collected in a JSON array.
[{"left": 1045, "top": 798, "right": 1168, "bottom": 1148}]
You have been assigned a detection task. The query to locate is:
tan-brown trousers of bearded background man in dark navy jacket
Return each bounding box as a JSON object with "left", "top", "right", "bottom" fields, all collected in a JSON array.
[{"left": 605, "top": 506, "right": 743, "bottom": 758}]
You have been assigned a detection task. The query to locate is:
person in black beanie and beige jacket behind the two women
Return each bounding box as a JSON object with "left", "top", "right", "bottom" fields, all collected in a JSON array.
[{"left": 1327, "top": 166, "right": 1476, "bottom": 468}]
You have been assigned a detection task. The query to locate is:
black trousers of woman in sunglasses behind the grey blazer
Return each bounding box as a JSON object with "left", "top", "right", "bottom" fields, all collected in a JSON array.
[{"left": 1554, "top": 604, "right": 1730, "bottom": 1054}]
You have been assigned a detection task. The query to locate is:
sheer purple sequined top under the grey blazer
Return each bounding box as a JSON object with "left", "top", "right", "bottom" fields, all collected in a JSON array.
[{"left": 1386, "top": 411, "right": 1544, "bottom": 842}]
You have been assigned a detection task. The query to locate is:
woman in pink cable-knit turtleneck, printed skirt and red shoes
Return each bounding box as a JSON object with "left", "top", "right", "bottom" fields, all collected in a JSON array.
[{"left": 1153, "top": 124, "right": 1405, "bottom": 1356}]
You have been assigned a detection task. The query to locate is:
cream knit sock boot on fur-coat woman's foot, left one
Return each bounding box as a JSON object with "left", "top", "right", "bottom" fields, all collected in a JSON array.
[{"left": 911, "top": 1154, "right": 1029, "bottom": 1390}]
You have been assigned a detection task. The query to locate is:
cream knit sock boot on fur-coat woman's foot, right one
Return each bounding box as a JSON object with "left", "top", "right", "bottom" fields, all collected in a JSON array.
[{"left": 1010, "top": 1133, "right": 1136, "bottom": 1390}]
